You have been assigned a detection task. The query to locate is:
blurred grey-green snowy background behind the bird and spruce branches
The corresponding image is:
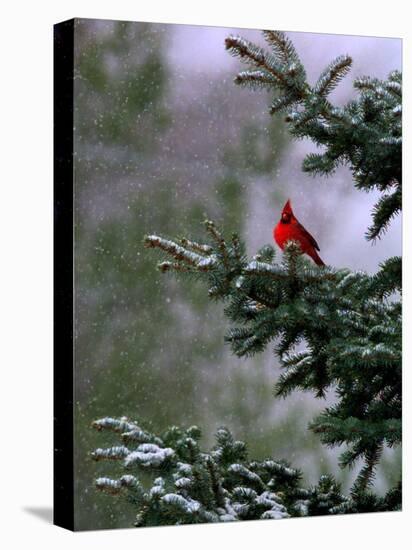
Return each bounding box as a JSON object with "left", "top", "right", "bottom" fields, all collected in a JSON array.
[{"left": 74, "top": 19, "right": 401, "bottom": 529}]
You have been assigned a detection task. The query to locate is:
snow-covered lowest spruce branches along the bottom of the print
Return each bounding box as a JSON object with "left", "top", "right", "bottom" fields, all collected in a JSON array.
[{"left": 91, "top": 418, "right": 400, "bottom": 527}]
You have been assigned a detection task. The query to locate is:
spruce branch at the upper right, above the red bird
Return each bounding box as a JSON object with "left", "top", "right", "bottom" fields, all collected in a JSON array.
[{"left": 226, "top": 31, "right": 402, "bottom": 240}]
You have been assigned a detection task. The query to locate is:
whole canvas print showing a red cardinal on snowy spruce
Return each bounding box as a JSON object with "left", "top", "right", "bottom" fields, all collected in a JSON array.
[{"left": 55, "top": 19, "right": 402, "bottom": 530}]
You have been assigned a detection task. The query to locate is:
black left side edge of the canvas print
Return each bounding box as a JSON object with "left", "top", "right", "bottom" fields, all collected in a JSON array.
[{"left": 53, "top": 19, "right": 74, "bottom": 531}]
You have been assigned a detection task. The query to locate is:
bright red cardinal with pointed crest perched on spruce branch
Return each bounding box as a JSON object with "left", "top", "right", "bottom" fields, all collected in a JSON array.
[{"left": 273, "top": 199, "right": 325, "bottom": 265}]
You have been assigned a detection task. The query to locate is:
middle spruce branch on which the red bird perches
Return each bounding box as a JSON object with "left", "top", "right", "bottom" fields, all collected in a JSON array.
[{"left": 146, "top": 221, "right": 401, "bottom": 498}]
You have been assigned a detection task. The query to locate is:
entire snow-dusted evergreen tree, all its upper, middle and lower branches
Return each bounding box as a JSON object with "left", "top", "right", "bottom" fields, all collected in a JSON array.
[{"left": 94, "top": 31, "right": 402, "bottom": 525}]
